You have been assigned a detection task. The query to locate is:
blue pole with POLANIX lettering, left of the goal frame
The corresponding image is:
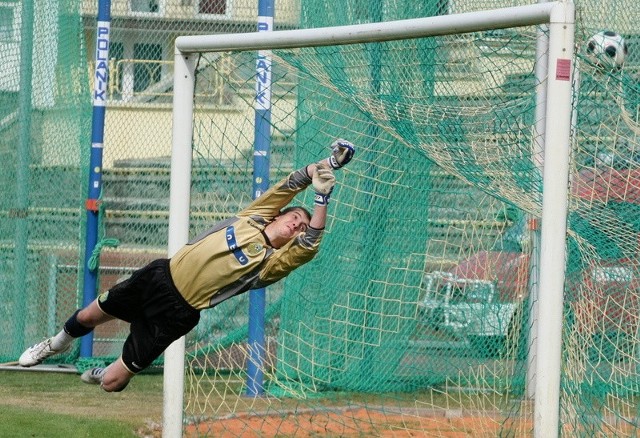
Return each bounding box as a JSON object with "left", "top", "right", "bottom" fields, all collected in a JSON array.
[{"left": 80, "top": 0, "right": 111, "bottom": 357}]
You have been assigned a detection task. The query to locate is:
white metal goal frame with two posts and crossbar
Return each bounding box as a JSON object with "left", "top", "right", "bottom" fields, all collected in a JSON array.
[{"left": 163, "top": 1, "right": 574, "bottom": 438}]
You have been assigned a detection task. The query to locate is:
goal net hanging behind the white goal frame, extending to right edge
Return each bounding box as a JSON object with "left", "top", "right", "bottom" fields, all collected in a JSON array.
[{"left": 170, "top": 1, "right": 640, "bottom": 436}]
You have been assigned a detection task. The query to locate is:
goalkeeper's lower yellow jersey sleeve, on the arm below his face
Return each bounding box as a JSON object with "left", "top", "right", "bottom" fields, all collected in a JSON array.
[{"left": 259, "top": 227, "right": 324, "bottom": 286}]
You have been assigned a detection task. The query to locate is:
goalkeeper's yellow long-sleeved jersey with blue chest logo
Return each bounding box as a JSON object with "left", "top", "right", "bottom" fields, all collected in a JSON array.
[{"left": 170, "top": 168, "right": 323, "bottom": 309}]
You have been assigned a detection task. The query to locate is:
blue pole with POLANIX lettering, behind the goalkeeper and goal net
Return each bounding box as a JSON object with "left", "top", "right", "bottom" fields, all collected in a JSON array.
[{"left": 247, "top": 0, "right": 275, "bottom": 397}]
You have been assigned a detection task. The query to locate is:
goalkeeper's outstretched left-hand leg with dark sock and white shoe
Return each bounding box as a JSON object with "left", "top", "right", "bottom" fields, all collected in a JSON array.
[{"left": 18, "top": 301, "right": 114, "bottom": 367}]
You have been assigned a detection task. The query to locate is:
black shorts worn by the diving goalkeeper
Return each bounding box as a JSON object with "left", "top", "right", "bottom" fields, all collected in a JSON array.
[{"left": 98, "top": 259, "right": 200, "bottom": 373}]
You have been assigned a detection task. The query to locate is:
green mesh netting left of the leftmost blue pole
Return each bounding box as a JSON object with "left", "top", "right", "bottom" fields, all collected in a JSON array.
[{"left": 0, "top": 1, "right": 91, "bottom": 362}]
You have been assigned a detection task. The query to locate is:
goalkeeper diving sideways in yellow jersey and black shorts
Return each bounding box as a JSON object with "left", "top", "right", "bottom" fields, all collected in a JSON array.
[{"left": 19, "top": 139, "right": 355, "bottom": 392}]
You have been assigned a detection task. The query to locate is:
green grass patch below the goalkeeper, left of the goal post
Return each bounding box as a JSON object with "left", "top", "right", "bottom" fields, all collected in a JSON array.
[{"left": 0, "top": 370, "right": 162, "bottom": 438}]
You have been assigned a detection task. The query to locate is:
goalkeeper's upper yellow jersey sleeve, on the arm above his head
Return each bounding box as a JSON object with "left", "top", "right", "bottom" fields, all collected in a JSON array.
[{"left": 238, "top": 166, "right": 311, "bottom": 221}]
